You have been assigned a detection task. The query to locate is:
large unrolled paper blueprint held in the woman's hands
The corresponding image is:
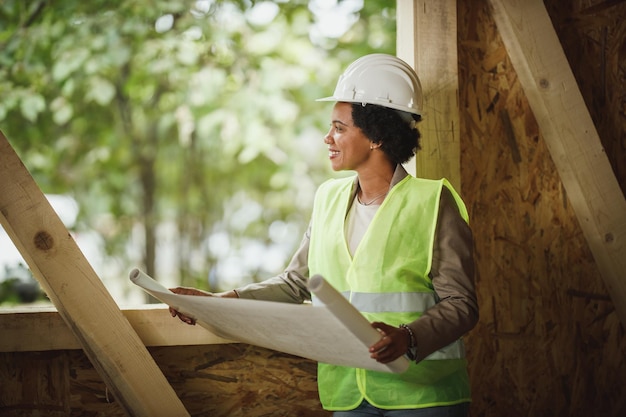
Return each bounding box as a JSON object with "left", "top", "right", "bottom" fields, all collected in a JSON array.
[{"left": 130, "top": 269, "right": 409, "bottom": 373}]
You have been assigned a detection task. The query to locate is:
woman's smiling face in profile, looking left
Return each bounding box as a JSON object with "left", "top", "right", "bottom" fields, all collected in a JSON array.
[{"left": 324, "top": 102, "right": 372, "bottom": 171}]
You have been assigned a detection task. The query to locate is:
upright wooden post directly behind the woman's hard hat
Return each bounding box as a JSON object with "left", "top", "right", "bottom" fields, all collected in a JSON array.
[{"left": 396, "top": 0, "right": 461, "bottom": 191}]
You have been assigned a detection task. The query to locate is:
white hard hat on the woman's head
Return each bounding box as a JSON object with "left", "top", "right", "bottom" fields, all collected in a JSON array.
[{"left": 317, "top": 54, "right": 422, "bottom": 116}]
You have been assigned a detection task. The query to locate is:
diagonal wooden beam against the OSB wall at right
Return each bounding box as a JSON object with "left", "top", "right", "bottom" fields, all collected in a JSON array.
[{"left": 490, "top": 0, "right": 626, "bottom": 324}]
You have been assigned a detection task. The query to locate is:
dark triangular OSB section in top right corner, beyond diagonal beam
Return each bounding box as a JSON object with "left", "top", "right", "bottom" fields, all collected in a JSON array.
[{"left": 546, "top": 0, "right": 626, "bottom": 194}]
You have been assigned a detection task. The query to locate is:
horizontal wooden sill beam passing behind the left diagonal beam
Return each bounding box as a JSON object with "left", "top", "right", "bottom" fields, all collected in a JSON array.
[{"left": 0, "top": 304, "right": 232, "bottom": 352}]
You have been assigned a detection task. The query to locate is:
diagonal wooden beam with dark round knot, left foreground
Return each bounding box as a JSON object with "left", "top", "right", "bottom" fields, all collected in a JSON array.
[{"left": 0, "top": 132, "right": 189, "bottom": 416}]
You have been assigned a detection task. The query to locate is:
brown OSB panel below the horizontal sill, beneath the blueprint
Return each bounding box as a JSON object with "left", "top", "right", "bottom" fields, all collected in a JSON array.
[{"left": 0, "top": 344, "right": 331, "bottom": 417}]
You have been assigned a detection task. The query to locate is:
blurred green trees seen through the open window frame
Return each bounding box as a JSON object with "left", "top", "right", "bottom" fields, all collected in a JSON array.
[{"left": 0, "top": 0, "right": 395, "bottom": 301}]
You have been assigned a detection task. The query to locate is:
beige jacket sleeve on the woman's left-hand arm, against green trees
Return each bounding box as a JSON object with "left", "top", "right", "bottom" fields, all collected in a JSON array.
[{"left": 235, "top": 221, "right": 311, "bottom": 304}]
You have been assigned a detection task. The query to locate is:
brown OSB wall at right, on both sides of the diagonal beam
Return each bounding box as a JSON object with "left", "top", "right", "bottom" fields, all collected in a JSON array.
[{"left": 458, "top": 0, "right": 626, "bottom": 417}]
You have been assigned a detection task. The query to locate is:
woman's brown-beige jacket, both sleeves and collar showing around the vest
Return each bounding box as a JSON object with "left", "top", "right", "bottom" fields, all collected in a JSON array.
[{"left": 236, "top": 166, "right": 478, "bottom": 361}]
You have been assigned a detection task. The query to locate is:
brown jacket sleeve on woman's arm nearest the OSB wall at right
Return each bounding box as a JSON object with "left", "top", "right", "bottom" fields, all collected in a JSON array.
[{"left": 408, "top": 187, "right": 478, "bottom": 361}]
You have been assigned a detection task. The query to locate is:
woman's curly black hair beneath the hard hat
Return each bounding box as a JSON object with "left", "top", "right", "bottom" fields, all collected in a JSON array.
[{"left": 352, "top": 103, "right": 422, "bottom": 164}]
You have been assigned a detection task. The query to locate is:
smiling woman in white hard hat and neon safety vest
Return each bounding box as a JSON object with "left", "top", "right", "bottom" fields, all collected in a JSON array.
[{"left": 171, "top": 54, "right": 478, "bottom": 417}]
